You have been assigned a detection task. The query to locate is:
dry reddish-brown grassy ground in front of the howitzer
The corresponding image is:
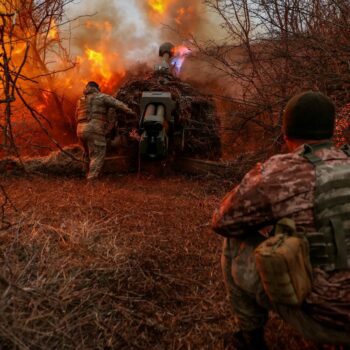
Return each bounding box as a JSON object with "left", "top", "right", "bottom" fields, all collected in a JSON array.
[{"left": 0, "top": 175, "right": 316, "bottom": 350}]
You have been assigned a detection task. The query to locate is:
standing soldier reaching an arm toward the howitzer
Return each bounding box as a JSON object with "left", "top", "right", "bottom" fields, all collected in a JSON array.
[{"left": 76, "top": 81, "right": 136, "bottom": 180}]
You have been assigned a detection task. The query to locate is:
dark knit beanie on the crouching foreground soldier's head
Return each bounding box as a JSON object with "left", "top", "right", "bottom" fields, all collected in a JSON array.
[{"left": 283, "top": 91, "right": 335, "bottom": 140}]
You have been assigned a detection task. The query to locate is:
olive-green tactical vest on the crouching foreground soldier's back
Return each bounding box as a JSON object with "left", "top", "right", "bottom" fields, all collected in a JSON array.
[{"left": 301, "top": 143, "right": 350, "bottom": 271}]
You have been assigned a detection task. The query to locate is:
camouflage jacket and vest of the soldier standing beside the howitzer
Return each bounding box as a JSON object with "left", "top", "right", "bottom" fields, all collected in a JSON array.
[{"left": 76, "top": 87, "right": 132, "bottom": 134}]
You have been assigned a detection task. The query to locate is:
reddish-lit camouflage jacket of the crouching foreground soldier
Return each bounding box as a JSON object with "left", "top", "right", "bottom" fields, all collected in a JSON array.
[{"left": 213, "top": 147, "right": 350, "bottom": 331}]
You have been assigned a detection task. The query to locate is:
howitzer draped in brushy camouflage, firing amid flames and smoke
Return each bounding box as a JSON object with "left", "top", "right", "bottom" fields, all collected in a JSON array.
[{"left": 102, "top": 43, "right": 221, "bottom": 174}]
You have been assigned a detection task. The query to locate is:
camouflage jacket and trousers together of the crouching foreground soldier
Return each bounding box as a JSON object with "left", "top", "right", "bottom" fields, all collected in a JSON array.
[{"left": 213, "top": 147, "right": 350, "bottom": 344}]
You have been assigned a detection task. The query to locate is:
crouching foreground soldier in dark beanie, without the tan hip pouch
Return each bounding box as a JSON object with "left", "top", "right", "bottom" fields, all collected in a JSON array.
[{"left": 213, "top": 92, "right": 350, "bottom": 349}]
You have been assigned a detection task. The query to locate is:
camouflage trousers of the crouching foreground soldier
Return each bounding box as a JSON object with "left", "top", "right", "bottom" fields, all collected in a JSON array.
[{"left": 221, "top": 235, "right": 350, "bottom": 345}]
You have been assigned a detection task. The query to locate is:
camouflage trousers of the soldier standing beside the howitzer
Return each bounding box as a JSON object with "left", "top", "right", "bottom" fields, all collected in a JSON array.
[{"left": 77, "top": 128, "right": 107, "bottom": 180}]
